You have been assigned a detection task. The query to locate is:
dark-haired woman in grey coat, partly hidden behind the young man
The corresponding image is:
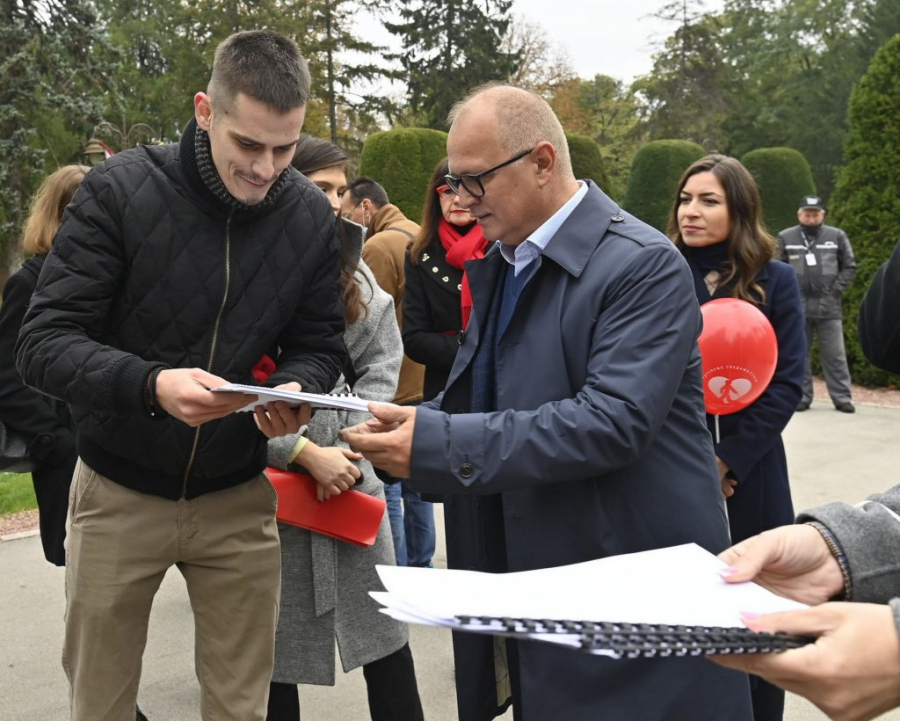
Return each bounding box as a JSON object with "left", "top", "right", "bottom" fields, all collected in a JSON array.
[{"left": 267, "top": 136, "right": 423, "bottom": 721}]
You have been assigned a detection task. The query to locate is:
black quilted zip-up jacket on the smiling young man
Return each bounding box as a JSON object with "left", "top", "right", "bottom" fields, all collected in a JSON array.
[{"left": 16, "top": 122, "right": 345, "bottom": 499}]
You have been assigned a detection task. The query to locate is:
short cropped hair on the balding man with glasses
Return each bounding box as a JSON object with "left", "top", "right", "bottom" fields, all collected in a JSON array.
[{"left": 447, "top": 83, "right": 572, "bottom": 175}]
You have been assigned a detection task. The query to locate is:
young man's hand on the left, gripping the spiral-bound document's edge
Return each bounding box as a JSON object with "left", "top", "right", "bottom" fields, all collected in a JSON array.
[{"left": 156, "top": 368, "right": 255, "bottom": 427}]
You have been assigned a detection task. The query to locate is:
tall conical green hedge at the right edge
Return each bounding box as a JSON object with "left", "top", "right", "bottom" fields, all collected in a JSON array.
[{"left": 825, "top": 35, "right": 900, "bottom": 387}]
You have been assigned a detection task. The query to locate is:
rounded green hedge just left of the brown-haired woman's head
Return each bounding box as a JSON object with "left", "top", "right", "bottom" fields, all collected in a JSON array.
[{"left": 622, "top": 140, "right": 707, "bottom": 233}]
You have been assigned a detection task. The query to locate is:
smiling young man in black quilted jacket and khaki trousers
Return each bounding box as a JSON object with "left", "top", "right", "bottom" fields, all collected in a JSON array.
[{"left": 17, "top": 32, "right": 344, "bottom": 721}]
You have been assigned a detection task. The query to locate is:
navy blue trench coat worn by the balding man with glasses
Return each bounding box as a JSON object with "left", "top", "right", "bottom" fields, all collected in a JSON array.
[{"left": 411, "top": 183, "right": 750, "bottom": 721}]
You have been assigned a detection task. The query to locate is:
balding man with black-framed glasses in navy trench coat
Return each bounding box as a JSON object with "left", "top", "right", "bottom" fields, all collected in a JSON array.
[{"left": 344, "top": 86, "right": 751, "bottom": 721}]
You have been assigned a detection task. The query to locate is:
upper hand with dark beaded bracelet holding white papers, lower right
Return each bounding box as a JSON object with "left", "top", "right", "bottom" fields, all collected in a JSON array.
[{"left": 719, "top": 524, "right": 844, "bottom": 605}]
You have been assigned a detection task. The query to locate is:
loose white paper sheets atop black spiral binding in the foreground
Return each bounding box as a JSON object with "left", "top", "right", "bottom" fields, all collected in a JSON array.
[{"left": 371, "top": 544, "right": 805, "bottom": 655}]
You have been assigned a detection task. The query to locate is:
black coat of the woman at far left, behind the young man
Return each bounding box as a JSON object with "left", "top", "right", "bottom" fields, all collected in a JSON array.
[{"left": 0, "top": 255, "right": 76, "bottom": 566}]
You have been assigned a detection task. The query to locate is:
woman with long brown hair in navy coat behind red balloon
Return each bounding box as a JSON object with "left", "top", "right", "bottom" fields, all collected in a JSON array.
[{"left": 668, "top": 155, "right": 806, "bottom": 721}]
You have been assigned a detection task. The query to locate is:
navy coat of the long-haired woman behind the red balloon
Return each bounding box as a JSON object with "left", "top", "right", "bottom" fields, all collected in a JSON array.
[{"left": 688, "top": 250, "right": 806, "bottom": 543}]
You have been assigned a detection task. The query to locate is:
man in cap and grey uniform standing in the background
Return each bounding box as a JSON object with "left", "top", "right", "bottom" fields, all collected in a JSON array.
[{"left": 778, "top": 195, "right": 856, "bottom": 413}]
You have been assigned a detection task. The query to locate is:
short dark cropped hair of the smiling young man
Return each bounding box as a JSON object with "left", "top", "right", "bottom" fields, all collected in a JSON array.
[{"left": 207, "top": 30, "right": 310, "bottom": 113}]
